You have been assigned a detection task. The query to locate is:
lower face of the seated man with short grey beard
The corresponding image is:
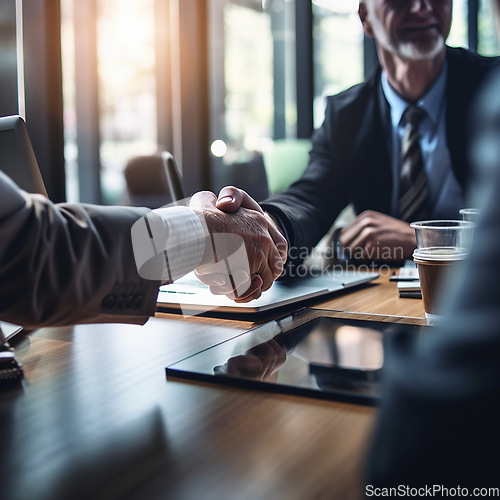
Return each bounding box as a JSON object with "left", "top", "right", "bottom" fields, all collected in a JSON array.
[{"left": 360, "top": 0, "right": 452, "bottom": 60}]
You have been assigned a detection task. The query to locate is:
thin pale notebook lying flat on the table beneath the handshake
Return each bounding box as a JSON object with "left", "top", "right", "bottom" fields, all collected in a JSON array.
[{"left": 157, "top": 270, "right": 379, "bottom": 315}]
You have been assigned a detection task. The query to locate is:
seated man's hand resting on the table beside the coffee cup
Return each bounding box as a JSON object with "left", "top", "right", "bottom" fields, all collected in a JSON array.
[{"left": 340, "top": 210, "right": 417, "bottom": 261}]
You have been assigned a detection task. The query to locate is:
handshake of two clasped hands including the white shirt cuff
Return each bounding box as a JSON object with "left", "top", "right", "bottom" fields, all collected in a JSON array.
[{"left": 132, "top": 187, "right": 288, "bottom": 302}]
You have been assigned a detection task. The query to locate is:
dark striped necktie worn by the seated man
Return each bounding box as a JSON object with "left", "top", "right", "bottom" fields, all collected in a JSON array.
[{"left": 398, "top": 106, "right": 429, "bottom": 222}]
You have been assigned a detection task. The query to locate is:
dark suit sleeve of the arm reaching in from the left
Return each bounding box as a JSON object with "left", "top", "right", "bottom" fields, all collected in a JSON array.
[{"left": 0, "top": 172, "right": 159, "bottom": 327}]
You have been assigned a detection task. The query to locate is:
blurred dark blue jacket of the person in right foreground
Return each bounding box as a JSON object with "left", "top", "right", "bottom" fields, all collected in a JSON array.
[{"left": 365, "top": 67, "right": 500, "bottom": 488}]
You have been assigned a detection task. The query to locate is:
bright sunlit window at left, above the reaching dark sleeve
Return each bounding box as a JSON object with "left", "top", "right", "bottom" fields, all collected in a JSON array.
[{"left": 61, "top": 0, "right": 157, "bottom": 204}]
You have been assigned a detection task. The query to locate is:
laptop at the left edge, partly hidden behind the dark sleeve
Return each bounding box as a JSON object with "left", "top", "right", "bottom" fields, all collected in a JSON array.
[{"left": 0, "top": 115, "right": 47, "bottom": 340}]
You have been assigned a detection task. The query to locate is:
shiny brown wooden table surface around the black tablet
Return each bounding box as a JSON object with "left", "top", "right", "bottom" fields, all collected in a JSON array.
[{"left": 0, "top": 272, "right": 425, "bottom": 500}]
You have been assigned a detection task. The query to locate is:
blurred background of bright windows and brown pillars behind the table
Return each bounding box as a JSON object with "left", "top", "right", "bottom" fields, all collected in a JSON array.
[{"left": 0, "top": 0, "right": 499, "bottom": 204}]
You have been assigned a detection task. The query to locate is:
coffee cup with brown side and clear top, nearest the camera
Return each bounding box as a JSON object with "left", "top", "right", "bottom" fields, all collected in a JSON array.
[{"left": 410, "top": 220, "right": 475, "bottom": 324}]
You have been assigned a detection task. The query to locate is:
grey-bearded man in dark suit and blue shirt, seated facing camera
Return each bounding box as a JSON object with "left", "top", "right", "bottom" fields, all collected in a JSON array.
[{"left": 262, "top": 0, "right": 498, "bottom": 274}]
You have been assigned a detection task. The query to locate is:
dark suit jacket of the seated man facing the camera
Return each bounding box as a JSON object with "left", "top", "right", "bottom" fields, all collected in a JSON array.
[{"left": 262, "top": 47, "right": 498, "bottom": 266}]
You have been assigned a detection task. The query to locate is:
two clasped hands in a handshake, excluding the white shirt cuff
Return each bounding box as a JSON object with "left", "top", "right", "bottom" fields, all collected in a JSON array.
[{"left": 190, "top": 187, "right": 287, "bottom": 302}]
